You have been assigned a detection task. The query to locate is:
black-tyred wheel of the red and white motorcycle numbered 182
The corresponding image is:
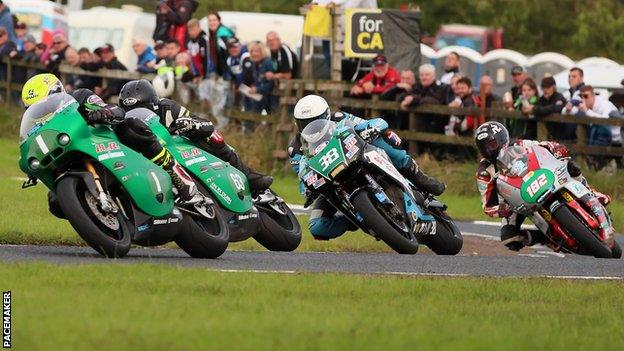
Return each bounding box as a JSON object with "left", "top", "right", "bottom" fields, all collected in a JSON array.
[{"left": 553, "top": 206, "right": 613, "bottom": 258}]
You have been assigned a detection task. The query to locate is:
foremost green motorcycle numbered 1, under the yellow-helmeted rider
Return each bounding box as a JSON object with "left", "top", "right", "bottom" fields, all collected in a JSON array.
[{"left": 19, "top": 93, "right": 229, "bottom": 258}]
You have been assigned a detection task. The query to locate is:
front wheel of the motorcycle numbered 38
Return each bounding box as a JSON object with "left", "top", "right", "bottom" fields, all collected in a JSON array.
[{"left": 353, "top": 191, "right": 418, "bottom": 254}]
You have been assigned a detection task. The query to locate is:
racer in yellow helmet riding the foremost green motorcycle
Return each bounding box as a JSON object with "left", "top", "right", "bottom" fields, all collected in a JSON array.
[{"left": 22, "top": 73, "right": 197, "bottom": 201}]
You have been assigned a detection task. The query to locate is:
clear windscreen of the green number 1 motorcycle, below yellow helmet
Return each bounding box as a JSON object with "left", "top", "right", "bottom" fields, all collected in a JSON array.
[{"left": 20, "top": 93, "right": 77, "bottom": 143}]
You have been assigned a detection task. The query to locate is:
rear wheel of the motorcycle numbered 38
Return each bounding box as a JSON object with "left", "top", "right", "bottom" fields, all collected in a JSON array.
[{"left": 418, "top": 212, "right": 464, "bottom": 255}]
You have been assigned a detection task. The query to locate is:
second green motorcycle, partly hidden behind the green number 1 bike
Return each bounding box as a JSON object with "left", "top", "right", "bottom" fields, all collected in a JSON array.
[{"left": 126, "top": 108, "right": 301, "bottom": 251}]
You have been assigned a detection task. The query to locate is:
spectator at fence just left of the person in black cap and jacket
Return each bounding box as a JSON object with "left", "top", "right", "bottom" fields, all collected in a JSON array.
[{"left": 507, "top": 78, "right": 538, "bottom": 140}]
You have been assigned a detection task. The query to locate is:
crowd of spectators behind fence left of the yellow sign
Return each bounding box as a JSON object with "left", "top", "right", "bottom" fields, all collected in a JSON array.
[{"left": 0, "top": 0, "right": 299, "bottom": 119}]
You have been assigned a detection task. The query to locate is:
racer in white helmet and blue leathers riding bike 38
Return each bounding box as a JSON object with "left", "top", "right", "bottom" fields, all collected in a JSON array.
[{"left": 288, "top": 95, "right": 446, "bottom": 240}]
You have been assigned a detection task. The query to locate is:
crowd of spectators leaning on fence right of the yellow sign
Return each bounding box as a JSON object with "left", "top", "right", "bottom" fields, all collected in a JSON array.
[{"left": 349, "top": 52, "right": 622, "bottom": 154}]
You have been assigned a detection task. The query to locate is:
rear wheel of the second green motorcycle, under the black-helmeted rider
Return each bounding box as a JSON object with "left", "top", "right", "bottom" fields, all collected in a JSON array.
[{"left": 254, "top": 199, "right": 301, "bottom": 251}]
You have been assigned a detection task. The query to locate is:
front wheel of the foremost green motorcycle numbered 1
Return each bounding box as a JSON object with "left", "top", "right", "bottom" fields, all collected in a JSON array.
[{"left": 56, "top": 176, "right": 134, "bottom": 258}]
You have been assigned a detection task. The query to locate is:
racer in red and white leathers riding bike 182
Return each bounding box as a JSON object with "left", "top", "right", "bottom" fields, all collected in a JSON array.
[{"left": 475, "top": 121, "right": 611, "bottom": 251}]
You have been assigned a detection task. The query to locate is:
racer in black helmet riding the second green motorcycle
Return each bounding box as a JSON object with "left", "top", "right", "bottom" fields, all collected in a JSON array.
[{"left": 119, "top": 79, "right": 273, "bottom": 193}]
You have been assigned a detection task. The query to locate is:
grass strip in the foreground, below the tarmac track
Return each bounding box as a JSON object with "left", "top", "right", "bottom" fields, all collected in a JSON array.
[{"left": 2, "top": 263, "right": 624, "bottom": 351}]
